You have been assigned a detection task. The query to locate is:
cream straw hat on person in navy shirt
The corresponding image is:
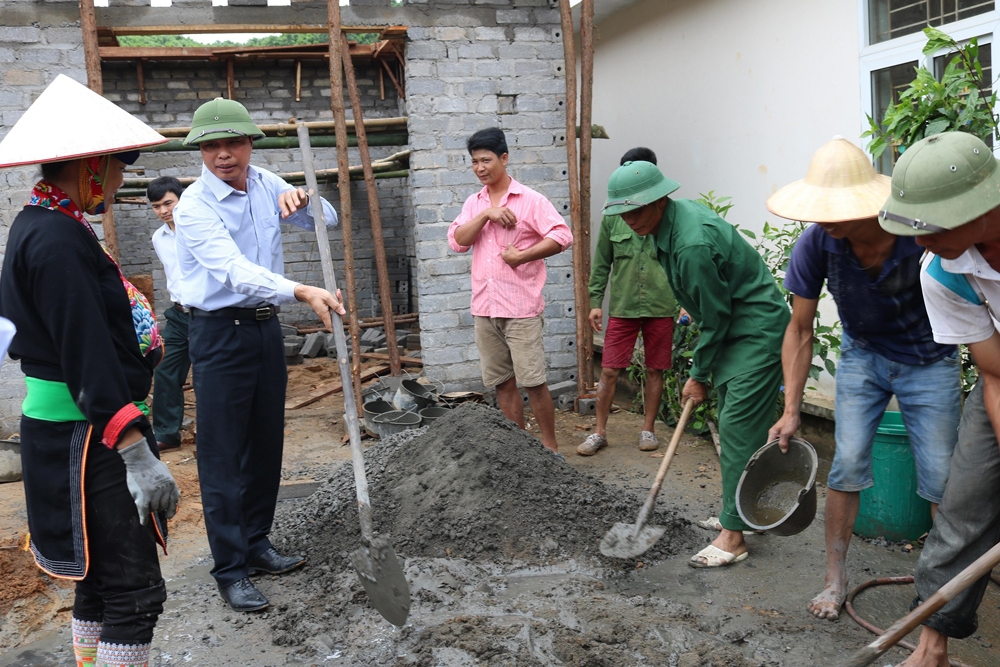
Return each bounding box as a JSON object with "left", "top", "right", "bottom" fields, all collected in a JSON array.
[{"left": 767, "top": 137, "right": 890, "bottom": 222}]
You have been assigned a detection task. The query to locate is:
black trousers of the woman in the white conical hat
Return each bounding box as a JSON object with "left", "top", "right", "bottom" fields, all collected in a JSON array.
[{"left": 73, "top": 434, "right": 167, "bottom": 645}]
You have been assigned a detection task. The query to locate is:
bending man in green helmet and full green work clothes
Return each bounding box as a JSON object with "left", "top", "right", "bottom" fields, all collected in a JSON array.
[{"left": 604, "top": 162, "right": 789, "bottom": 567}]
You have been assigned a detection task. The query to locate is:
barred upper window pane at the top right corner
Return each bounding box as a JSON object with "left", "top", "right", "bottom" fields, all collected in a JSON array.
[{"left": 868, "top": 0, "right": 996, "bottom": 44}]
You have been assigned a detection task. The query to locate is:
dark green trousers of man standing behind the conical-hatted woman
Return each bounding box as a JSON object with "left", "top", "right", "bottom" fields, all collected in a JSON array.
[{"left": 153, "top": 306, "right": 191, "bottom": 445}]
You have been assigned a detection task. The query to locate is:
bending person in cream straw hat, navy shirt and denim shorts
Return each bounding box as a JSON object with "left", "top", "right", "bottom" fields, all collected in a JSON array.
[{"left": 767, "top": 137, "right": 961, "bottom": 620}]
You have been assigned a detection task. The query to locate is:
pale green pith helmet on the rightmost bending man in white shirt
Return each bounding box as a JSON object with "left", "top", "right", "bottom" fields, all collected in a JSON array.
[{"left": 879, "top": 132, "right": 1000, "bottom": 236}]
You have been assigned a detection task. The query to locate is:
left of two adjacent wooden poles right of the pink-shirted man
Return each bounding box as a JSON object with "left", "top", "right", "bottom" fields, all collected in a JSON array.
[{"left": 559, "top": 0, "right": 590, "bottom": 396}]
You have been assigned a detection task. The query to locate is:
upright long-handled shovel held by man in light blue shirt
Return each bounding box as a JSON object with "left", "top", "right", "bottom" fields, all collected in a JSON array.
[{"left": 298, "top": 125, "right": 410, "bottom": 627}]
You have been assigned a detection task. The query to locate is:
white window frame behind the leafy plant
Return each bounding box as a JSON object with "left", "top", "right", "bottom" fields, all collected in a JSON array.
[{"left": 858, "top": 0, "right": 1000, "bottom": 152}]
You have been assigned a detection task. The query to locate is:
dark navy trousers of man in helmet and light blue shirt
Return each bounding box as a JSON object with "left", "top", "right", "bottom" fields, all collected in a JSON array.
[{"left": 189, "top": 317, "right": 288, "bottom": 586}]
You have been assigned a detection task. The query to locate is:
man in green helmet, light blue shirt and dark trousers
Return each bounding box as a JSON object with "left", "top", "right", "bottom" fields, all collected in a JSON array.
[{"left": 174, "top": 98, "right": 344, "bottom": 611}]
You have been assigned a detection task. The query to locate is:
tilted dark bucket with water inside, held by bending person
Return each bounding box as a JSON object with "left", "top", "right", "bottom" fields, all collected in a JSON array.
[{"left": 736, "top": 438, "right": 819, "bottom": 536}]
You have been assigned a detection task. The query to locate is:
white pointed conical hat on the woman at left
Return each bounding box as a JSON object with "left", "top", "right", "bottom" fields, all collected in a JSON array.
[{"left": 0, "top": 74, "right": 166, "bottom": 167}]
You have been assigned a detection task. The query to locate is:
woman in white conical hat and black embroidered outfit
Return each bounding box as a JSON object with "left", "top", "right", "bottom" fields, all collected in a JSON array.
[{"left": 0, "top": 75, "right": 179, "bottom": 667}]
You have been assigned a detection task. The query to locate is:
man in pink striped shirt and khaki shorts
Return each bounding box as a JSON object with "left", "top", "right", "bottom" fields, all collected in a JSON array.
[{"left": 448, "top": 128, "right": 573, "bottom": 454}]
